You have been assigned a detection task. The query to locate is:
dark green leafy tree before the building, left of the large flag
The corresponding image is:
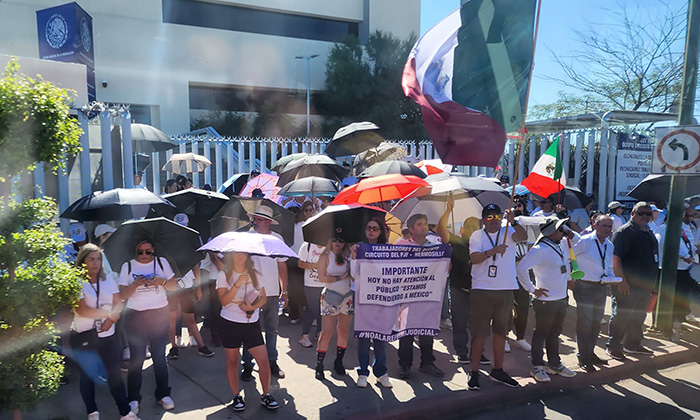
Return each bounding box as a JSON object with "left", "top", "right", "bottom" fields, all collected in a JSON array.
[{"left": 315, "top": 31, "right": 427, "bottom": 139}]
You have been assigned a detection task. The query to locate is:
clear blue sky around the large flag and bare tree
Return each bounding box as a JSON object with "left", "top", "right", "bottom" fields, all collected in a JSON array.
[{"left": 420, "top": 0, "right": 698, "bottom": 115}]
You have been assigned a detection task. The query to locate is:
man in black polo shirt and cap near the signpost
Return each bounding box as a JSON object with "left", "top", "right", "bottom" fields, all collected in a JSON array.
[{"left": 607, "top": 201, "right": 659, "bottom": 360}]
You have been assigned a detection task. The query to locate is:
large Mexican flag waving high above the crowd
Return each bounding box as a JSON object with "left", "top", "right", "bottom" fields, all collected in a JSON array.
[{"left": 401, "top": 0, "right": 535, "bottom": 167}]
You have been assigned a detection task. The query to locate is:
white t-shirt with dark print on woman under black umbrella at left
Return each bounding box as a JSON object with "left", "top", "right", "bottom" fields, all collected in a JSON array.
[{"left": 119, "top": 258, "right": 175, "bottom": 311}]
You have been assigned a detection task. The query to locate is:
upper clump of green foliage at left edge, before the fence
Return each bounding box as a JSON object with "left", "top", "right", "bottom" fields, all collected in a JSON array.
[{"left": 0, "top": 60, "right": 81, "bottom": 182}]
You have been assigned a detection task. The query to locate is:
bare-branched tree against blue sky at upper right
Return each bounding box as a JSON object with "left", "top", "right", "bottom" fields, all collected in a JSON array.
[{"left": 550, "top": 0, "right": 686, "bottom": 115}]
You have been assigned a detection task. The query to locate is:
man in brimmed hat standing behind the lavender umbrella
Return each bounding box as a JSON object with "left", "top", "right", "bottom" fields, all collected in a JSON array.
[{"left": 241, "top": 205, "right": 287, "bottom": 382}]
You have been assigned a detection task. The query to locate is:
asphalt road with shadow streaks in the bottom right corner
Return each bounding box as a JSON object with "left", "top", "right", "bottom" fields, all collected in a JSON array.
[{"left": 462, "top": 363, "right": 700, "bottom": 420}]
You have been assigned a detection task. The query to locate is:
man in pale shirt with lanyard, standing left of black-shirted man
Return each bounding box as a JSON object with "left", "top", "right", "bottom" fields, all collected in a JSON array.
[{"left": 573, "top": 215, "right": 614, "bottom": 372}]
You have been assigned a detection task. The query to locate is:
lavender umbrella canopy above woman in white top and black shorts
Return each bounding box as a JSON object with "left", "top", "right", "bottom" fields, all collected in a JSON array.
[{"left": 198, "top": 232, "right": 298, "bottom": 258}]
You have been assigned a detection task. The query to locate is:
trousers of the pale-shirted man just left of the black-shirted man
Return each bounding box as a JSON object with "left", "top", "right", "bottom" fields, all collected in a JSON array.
[{"left": 574, "top": 280, "right": 606, "bottom": 362}]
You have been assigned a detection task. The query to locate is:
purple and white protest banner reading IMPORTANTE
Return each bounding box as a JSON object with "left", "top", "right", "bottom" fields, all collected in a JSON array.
[{"left": 355, "top": 244, "right": 451, "bottom": 341}]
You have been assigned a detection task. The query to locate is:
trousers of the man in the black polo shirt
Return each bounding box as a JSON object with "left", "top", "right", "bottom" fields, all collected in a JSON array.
[{"left": 608, "top": 286, "right": 651, "bottom": 350}]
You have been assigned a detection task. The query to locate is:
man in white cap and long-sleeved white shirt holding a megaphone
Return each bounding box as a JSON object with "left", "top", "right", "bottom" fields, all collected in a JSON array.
[{"left": 518, "top": 216, "right": 576, "bottom": 382}]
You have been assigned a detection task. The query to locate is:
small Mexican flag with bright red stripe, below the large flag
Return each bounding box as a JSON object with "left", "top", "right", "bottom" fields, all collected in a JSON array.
[{"left": 521, "top": 137, "right": 566, "bottom": 197}]
